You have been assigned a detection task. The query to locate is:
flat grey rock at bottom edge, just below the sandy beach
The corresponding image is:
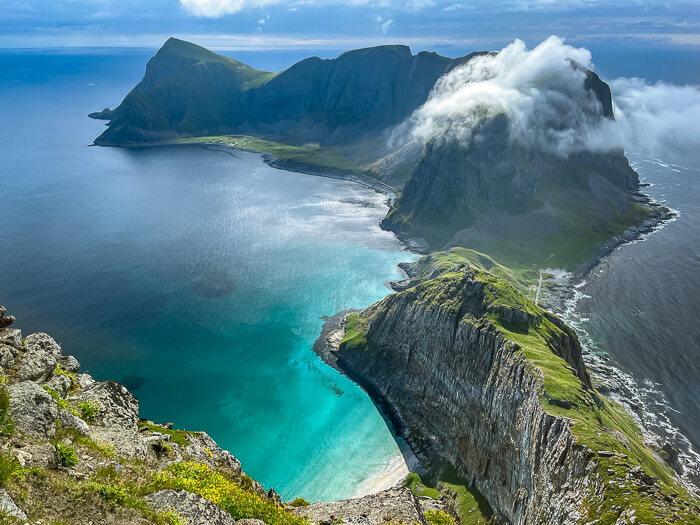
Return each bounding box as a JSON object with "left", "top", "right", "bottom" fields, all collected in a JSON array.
[{"left": 293, "top": 487, "right": 426, "bottom": 525}]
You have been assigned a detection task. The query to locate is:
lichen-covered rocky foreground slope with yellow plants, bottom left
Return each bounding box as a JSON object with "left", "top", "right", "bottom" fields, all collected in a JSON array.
[{"left": 0, "top": 306, "right": 455, "bottom": 525}]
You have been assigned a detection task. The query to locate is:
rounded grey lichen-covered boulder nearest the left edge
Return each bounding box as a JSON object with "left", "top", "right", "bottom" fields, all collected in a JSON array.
[{"left": 7, "top": 381, "right": 58, "bottom": 439}]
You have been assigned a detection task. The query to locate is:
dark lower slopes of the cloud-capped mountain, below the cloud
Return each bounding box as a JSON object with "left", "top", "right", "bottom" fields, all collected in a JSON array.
[{"left": 382, "top": 115, "right": 639, "bottom": 249}]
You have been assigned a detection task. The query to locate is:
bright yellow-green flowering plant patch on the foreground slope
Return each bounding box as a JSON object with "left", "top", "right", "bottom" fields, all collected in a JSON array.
[{"left": 148, "top": 462, "right": 307, "bottom": 525}]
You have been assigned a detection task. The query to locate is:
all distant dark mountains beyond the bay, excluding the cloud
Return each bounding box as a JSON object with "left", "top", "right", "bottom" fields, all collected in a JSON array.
[{"left": 90, "top": 38, "right": 660, "bottom": 269}]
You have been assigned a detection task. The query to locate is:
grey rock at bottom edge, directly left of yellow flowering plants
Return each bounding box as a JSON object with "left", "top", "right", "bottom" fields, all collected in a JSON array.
[{"left": 146, "top": 489, "right": 236, "bottom": 525}]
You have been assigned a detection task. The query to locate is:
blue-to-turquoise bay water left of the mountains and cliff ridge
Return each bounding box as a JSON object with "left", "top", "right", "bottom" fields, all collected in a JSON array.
[{"left": 0, "top": 53, "right": 413, "bottom": 500}]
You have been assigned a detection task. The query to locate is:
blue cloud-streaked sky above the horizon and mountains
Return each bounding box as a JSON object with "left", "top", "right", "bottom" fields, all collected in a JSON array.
[{"left": 0, "top": 0, "right": 700, "bottom": 54}]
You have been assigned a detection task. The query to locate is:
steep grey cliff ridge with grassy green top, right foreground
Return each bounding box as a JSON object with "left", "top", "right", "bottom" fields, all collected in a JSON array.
[{"left": 328, "top": 252, "right": 700, "bottom": 524}]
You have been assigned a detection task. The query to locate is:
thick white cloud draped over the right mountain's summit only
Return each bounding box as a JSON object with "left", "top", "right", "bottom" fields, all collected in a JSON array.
[{"left": 408, "top": 37, "right": 611, "bottom": 155}]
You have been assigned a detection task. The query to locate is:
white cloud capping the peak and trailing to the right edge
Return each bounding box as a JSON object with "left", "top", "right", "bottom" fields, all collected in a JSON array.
[{"left": 394, "top": 37, "right": 700, "bottom": 156}]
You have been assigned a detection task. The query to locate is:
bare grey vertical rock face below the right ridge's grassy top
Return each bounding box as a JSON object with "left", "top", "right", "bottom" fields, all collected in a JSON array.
[{"left": 330, "top": 270, "right": 591, "bottom": 524}]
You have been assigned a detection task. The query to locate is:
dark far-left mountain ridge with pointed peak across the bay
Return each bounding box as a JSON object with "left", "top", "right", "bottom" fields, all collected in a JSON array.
[{"left": 91, "top": 38, "right": 472, "bottom": 145}]
